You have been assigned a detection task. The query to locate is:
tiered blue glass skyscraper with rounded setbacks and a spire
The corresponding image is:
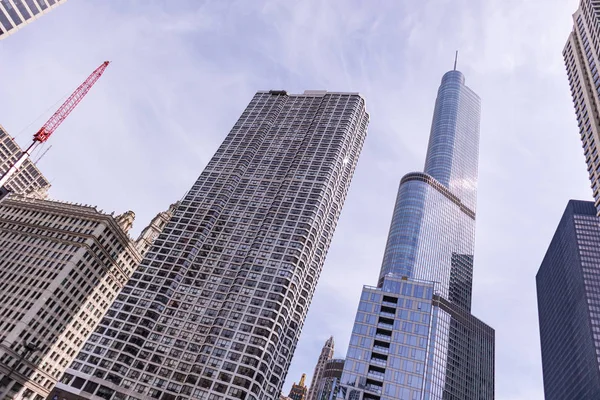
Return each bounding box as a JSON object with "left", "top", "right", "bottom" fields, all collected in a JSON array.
[{"left": 341, "top": 70, "right": 494, "bottom": 400}]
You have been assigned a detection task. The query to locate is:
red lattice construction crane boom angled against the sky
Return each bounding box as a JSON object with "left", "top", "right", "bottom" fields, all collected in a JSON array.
[{"left": 0, "top": 61, "right": 109, "bottom": 191}]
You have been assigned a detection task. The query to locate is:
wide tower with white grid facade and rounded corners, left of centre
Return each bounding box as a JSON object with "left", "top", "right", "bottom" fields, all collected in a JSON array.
[{"left": 57, "top": 91, "right": 369, "bottom": 400}]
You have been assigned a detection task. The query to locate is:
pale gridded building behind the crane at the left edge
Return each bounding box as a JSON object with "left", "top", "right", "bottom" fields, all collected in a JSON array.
[{"left": 0, "top": 125, "right": 50, "bottom": 198}]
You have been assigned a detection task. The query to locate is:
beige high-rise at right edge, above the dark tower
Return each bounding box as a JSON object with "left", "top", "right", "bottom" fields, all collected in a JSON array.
[{"left": 563, "top": 0, "right": 600, "bottom": 215}]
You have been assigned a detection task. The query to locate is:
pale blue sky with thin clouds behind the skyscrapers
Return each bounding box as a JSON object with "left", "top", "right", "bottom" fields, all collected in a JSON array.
[{"left": 0, "top": 0, "right": 591, "bottom": 400}]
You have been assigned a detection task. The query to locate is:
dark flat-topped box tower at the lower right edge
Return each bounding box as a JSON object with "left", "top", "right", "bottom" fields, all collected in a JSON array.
[{"left": 536, "top": 200, "right": 600, "bottom": 400}]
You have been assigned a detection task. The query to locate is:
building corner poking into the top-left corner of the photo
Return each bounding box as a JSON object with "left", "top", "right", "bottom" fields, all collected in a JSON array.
[{"left": 0, "top": 0, "right": 67, "bottom": 40}]
